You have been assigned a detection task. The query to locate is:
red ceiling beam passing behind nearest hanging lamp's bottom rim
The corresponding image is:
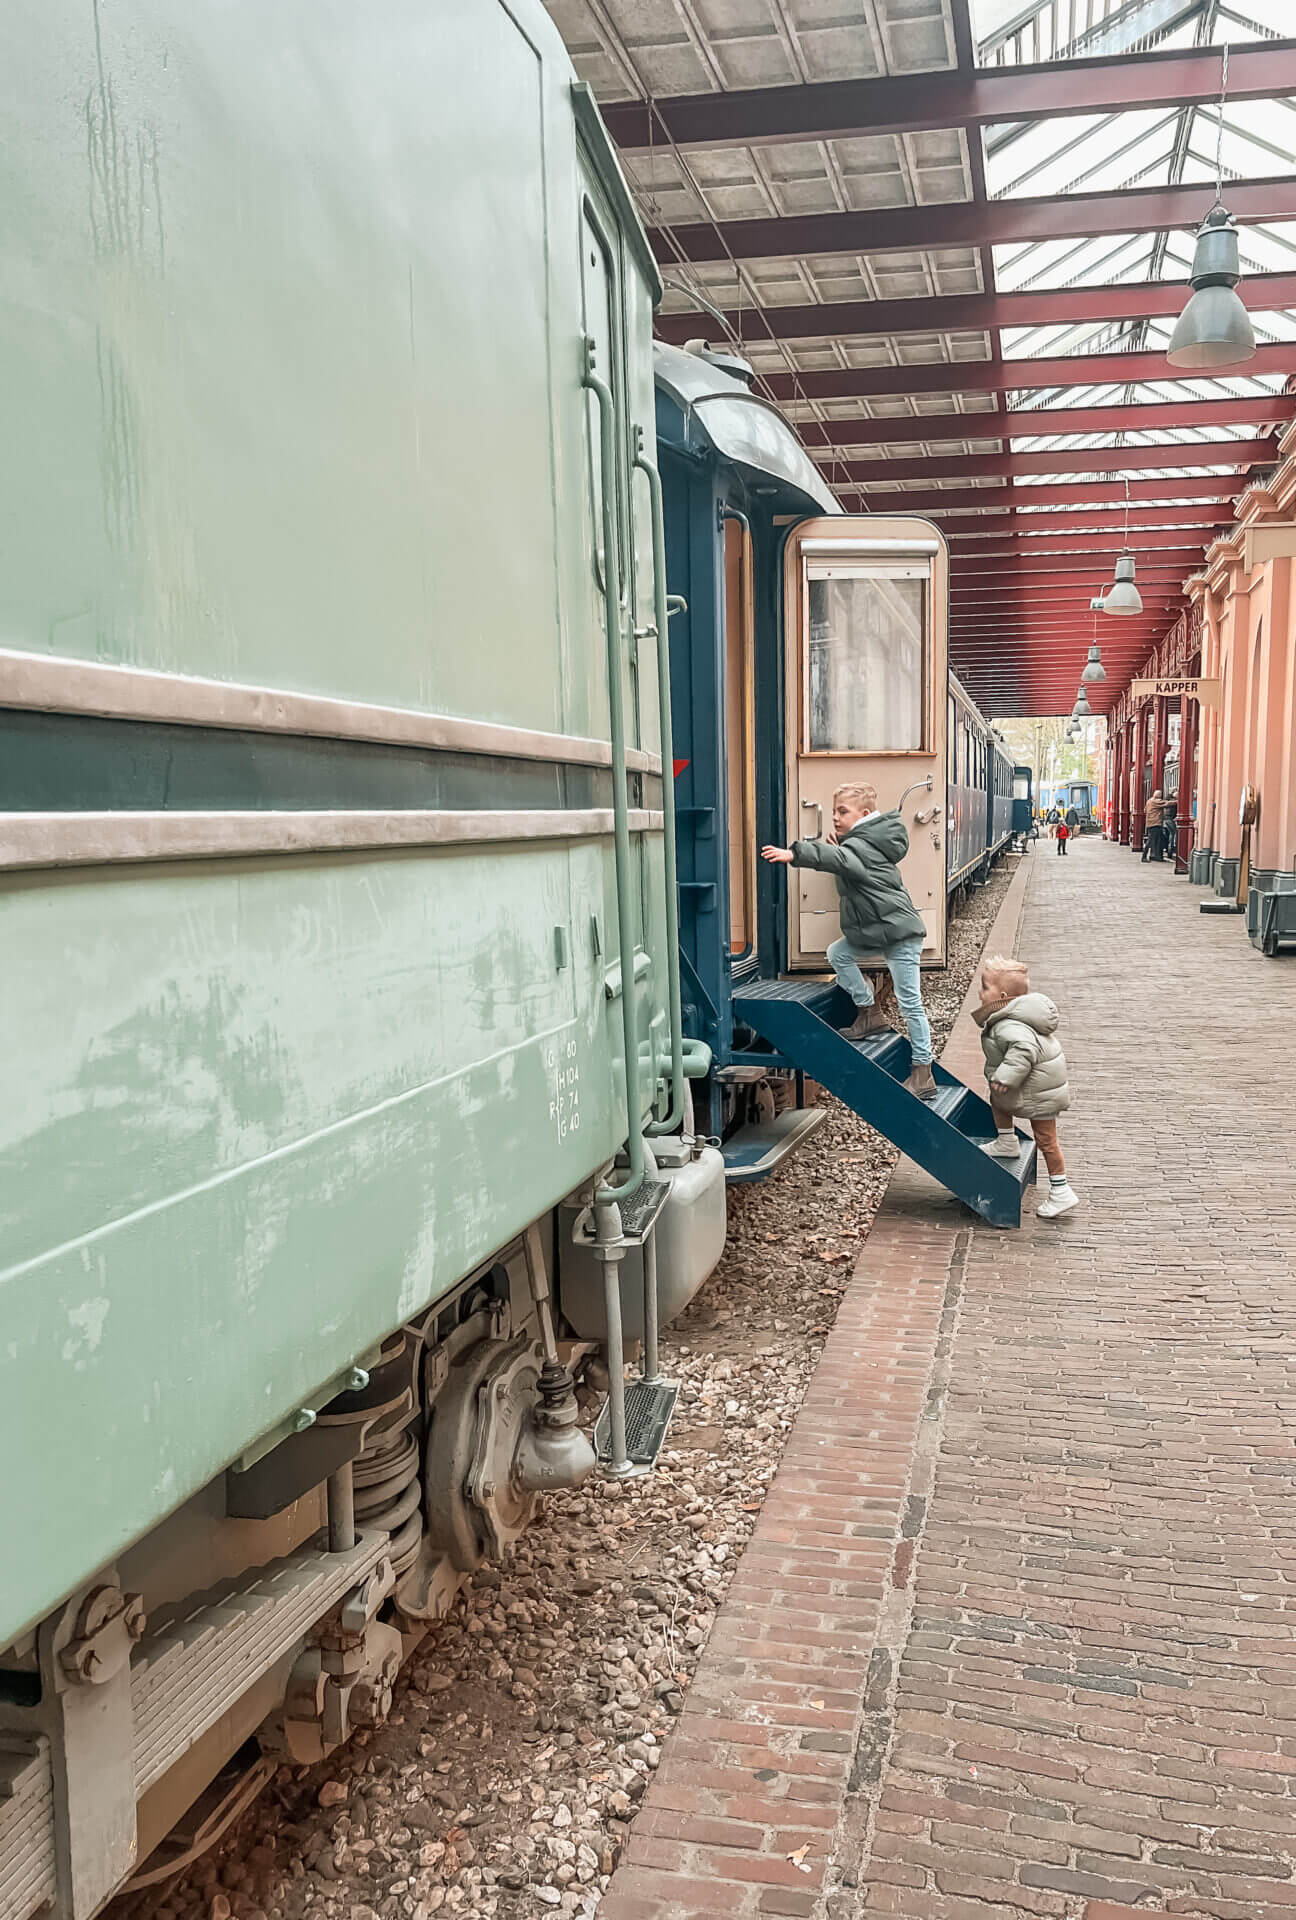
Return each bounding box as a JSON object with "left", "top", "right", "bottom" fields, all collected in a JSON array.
[{"left": 762, "top": 342, "right": 1296, "bottom": 401}]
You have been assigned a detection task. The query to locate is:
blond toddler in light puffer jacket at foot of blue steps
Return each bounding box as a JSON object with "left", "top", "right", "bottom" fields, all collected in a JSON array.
[{"left": 972, "top": 954, "right": 1079, "bottom": 1219}]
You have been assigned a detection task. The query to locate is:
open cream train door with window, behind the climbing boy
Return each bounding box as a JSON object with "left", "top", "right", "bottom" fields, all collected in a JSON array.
[{"left": 783, "top": 515, "right": 948, "bottom": 970}]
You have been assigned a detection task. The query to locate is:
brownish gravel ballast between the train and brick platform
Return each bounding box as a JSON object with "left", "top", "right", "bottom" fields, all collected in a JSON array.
[{"left": 113, "top": 870, "right": 1010, "bottom": 1920}]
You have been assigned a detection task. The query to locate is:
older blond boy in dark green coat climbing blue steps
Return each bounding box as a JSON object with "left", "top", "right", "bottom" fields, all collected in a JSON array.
[{"left": 760, "top": 785, "right": 937, "bottom": 1100}]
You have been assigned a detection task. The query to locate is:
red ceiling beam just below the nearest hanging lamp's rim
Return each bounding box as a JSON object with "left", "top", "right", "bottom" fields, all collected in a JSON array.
[{"left": 793, "top": 394, "right": 1296, "bottom": 447}]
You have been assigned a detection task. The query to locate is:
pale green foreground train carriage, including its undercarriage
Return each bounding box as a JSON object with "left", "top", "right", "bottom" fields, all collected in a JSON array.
[{"left": 0, "top": 0, "right": 724, "bottom": 1920}]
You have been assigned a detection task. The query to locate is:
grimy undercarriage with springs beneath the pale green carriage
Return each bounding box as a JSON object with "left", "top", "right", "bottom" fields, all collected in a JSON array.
[{"left": 0, "top": 1198, "right": 724, "bottom": 1920}]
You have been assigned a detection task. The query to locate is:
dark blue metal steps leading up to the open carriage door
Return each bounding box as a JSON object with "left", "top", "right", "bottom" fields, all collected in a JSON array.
[{"left": 733, "top": 979, "right": 1035, "bottom": 1227}]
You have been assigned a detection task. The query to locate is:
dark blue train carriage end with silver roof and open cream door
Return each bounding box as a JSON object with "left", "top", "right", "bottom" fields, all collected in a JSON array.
[{"left": 655, "top": 344, "right": 952, "bottom": 1179}]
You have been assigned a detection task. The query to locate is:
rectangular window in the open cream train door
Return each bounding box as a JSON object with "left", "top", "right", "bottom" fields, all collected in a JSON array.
[{"left": 803, "top": 561, "right": 931, "bottom": 753}]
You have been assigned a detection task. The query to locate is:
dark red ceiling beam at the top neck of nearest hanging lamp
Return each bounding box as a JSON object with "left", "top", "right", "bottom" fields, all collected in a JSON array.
[{"left": 649, "top": 173, "right": 1296, "bottom": 267}]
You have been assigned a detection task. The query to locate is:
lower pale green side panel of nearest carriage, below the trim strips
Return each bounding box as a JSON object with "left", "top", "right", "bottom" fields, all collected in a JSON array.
[{"left": 0, "top": 843, "right": 648, "bottom": 1644}]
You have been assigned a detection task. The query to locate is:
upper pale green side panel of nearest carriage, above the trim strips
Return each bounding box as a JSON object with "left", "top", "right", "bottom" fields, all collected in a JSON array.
[{"left": 0, "top": 0, "right": 589, "bottom": 732}]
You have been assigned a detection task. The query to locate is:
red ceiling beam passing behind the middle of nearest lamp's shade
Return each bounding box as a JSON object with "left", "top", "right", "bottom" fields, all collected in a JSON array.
[{"left": 657, "top": 273, "right": 1296, "bottom": 346}]
